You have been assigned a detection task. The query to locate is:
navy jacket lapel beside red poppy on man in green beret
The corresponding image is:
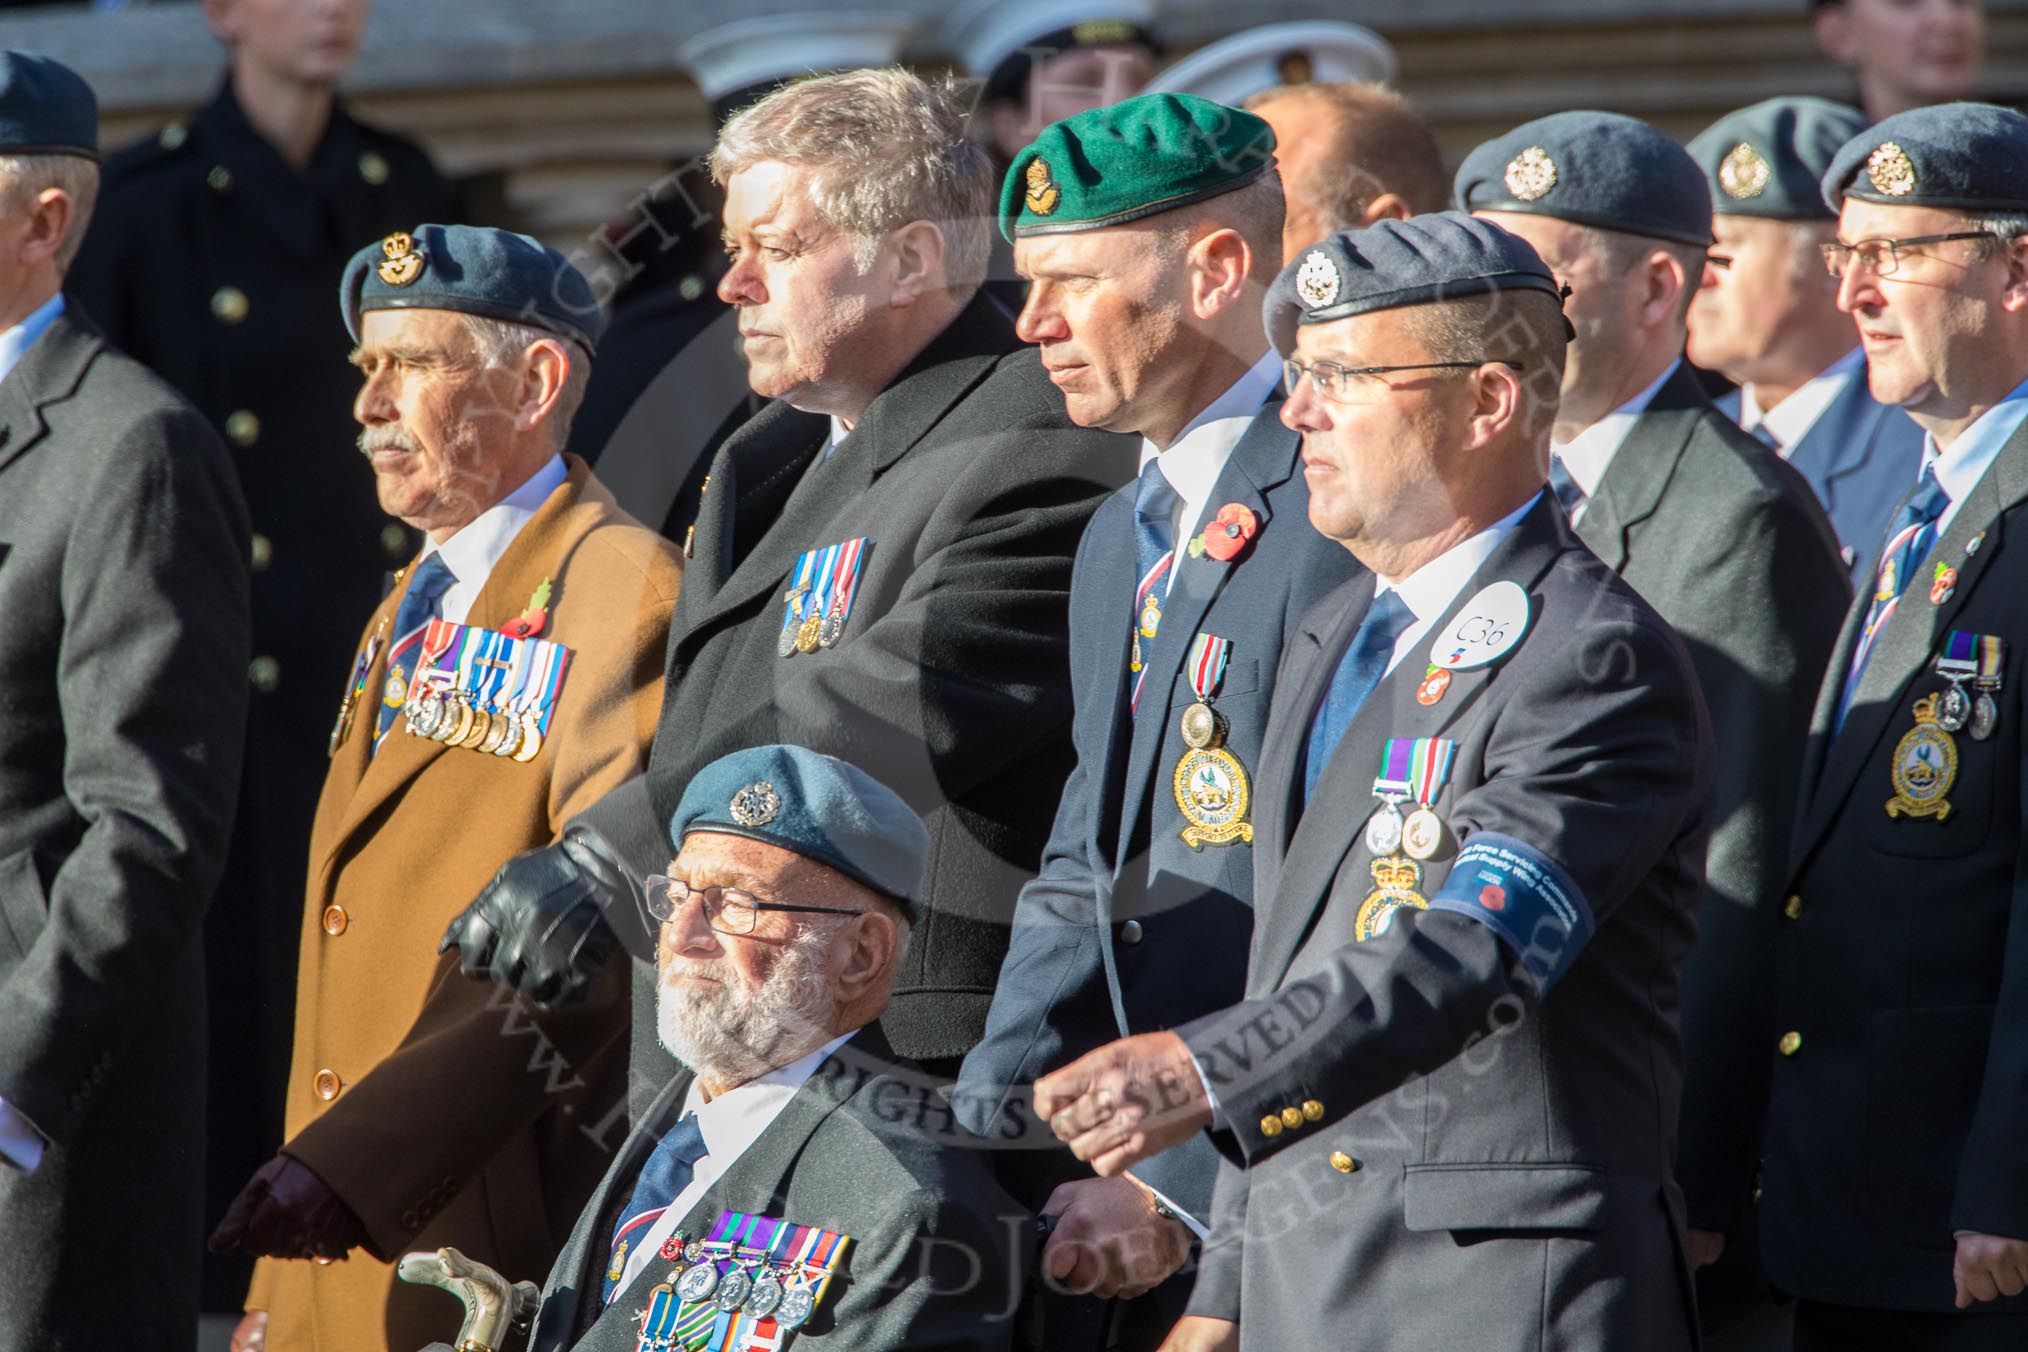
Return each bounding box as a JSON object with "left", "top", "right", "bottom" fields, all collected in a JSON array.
[{"left": 1113, "top": 399, "right": 1310, "bottom": 859}]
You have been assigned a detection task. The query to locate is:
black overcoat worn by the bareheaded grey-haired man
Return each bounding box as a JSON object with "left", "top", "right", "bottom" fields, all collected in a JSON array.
[{"left": 586, "top": 300, "right": 1136, "bottom": 1105}]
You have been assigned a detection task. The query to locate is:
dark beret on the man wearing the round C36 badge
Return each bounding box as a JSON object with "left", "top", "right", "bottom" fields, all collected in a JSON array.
[{"left": 1261, "top": 211, "right": 1564, "bottom": 357}]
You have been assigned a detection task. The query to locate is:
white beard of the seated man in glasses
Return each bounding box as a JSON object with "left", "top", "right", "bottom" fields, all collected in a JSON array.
[{"left": 655, "top": 928, "right": 831, "bottom": 1084}]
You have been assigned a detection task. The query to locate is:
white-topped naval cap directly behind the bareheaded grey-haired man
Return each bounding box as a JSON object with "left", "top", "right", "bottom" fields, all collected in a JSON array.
[{"left": 675, "top": 10, "right": 915, "bottom": 101}]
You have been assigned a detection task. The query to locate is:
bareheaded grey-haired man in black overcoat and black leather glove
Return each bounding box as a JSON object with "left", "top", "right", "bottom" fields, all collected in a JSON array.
[{"left": 446, "top": 71, "right": 1134, "bottom": 1107}]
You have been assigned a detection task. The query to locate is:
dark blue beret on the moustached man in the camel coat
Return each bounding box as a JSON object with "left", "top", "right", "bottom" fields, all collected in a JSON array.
[{"left": 339, "top": 225, "right": 606, "bottom": 353}]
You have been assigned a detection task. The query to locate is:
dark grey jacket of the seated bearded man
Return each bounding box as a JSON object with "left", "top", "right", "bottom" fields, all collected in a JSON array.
[{"left": 529, "top": 1026, "right": 1036, "bottom": 1352}]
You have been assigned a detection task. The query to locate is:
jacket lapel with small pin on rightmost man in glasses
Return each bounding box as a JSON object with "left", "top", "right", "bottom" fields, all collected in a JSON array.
[{"left": 1799, "top": 424, "right": 2028, "bottom": 847}]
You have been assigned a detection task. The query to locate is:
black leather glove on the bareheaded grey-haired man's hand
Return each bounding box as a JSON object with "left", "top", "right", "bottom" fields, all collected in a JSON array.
[{"left": 436, "top": 829, "right": 633, "bottom": 1009}]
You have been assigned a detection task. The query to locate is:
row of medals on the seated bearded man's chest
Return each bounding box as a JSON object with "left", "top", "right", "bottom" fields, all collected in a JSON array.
[{"left": 653, "top": 1212, "right": 852, "bottom": 1352}]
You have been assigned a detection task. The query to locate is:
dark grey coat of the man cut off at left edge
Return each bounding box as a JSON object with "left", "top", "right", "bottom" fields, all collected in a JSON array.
[{"left": 0, "top": 314, "right": 247, "bottom": 1352}]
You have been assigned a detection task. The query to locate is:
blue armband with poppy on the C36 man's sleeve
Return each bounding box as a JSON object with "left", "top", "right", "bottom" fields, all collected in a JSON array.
[{"left": 1430, "top": 831, "right": 1594, "bottom": 995}]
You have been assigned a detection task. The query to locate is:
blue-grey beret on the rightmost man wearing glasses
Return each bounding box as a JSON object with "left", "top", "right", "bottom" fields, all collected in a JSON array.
[{"left": 1821, "top": 103, "right": 2028, "bottom": 213}]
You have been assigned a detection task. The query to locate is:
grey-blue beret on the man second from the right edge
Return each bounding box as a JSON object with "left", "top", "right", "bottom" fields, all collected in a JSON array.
[{"left": 1689, "top": 97, "right": 1866, "bottom": 221}]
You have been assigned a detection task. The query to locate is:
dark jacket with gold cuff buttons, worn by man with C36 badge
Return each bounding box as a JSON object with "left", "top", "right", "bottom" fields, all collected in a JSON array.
[{"left": 1178, "top": 495, "right": 1712, "bottom": 1352}]
